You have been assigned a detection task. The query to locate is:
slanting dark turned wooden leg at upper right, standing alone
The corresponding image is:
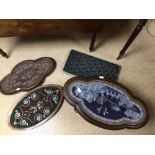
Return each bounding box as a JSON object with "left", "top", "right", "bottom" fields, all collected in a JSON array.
[{"left": 117, "top": 19, "right": 147, "bottom": 60}]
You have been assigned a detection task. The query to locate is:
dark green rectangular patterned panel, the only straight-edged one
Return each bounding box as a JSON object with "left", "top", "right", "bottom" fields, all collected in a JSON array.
[{"left": 63, "top": 50, "right": 121, "bottom": 80}]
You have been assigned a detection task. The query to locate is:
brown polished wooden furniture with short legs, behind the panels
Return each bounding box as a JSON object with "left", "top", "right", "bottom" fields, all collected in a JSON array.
[{"left": 0, "top": 19, "right": 103, "bottom": 58}]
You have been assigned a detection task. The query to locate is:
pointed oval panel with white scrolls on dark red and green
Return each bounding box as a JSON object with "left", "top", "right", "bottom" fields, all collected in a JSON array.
[{"left": 10, "top": 85, "right": 63, "bottom": 129}]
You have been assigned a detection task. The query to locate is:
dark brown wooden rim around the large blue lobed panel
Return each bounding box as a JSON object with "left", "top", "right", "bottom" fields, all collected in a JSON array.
[{"left": 63, "top": 77, "right": 149, "bottom": 130}]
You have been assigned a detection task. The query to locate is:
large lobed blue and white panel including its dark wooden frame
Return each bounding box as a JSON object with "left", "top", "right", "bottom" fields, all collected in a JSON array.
[{"left": 64, "top": 78, "right": 148, "bottom": 129}]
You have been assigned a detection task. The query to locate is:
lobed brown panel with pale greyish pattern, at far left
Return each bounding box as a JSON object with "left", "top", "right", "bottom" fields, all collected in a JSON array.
[{"left": 0, "top": 57, "right": 56, "bottom": 94}]
